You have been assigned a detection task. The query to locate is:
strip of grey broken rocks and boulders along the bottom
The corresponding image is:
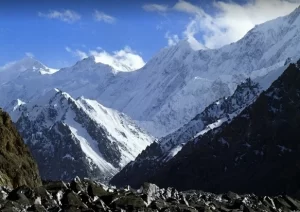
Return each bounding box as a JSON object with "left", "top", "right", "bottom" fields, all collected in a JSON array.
[{"left": 0, "top": 178, "right": 300, "bottom": 212}]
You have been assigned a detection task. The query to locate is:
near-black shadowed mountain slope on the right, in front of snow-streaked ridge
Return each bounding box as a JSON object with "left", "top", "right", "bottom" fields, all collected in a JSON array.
[{"left": 146, "top": 61, "right": 300, "bottom": 196}]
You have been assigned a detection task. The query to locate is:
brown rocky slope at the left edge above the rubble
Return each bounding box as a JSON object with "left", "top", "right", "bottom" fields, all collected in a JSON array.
[{"left": 0, "top": 109, "right": 41, "bottom": 187}]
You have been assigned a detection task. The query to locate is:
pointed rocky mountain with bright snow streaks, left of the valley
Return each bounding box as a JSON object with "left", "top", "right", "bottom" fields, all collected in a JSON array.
[{"left": 10, "top": 89, "right": 152, "bottom": 181}]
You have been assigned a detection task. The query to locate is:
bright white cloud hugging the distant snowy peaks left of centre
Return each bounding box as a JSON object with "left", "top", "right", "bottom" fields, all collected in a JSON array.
[{"left": 65, "top": 46, "right": 145, "bottom": 72}]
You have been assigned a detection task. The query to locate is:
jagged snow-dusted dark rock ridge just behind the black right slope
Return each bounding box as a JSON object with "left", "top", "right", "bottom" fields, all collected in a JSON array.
[{"left": 110, "top": 78, "right": 261, "bottom": 188}]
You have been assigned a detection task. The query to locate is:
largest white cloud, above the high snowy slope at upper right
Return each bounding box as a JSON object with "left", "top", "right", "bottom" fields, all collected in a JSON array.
[{"left": 173, "top": 0, "right": 300, "bottom": 48}]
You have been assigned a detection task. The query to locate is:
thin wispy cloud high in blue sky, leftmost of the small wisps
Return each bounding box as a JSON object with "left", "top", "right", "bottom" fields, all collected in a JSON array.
[{"left": 38, "top": 10, "right": 81, "bottom": 23}]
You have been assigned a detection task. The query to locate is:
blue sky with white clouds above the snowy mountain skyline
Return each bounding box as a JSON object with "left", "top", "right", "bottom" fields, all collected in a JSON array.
[{"left": 0, "top": 0, "right": 299, "bottom": 68}]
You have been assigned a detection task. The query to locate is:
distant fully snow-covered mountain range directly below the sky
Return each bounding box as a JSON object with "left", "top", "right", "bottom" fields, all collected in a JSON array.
[{"left": 0, "top": 8, "right": 300, "bottom": 137}]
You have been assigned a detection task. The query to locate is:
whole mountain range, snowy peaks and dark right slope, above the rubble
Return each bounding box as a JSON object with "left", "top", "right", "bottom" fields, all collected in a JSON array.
[{"left": 0, "top": 7, "right": 300, "bottom": 197}]
